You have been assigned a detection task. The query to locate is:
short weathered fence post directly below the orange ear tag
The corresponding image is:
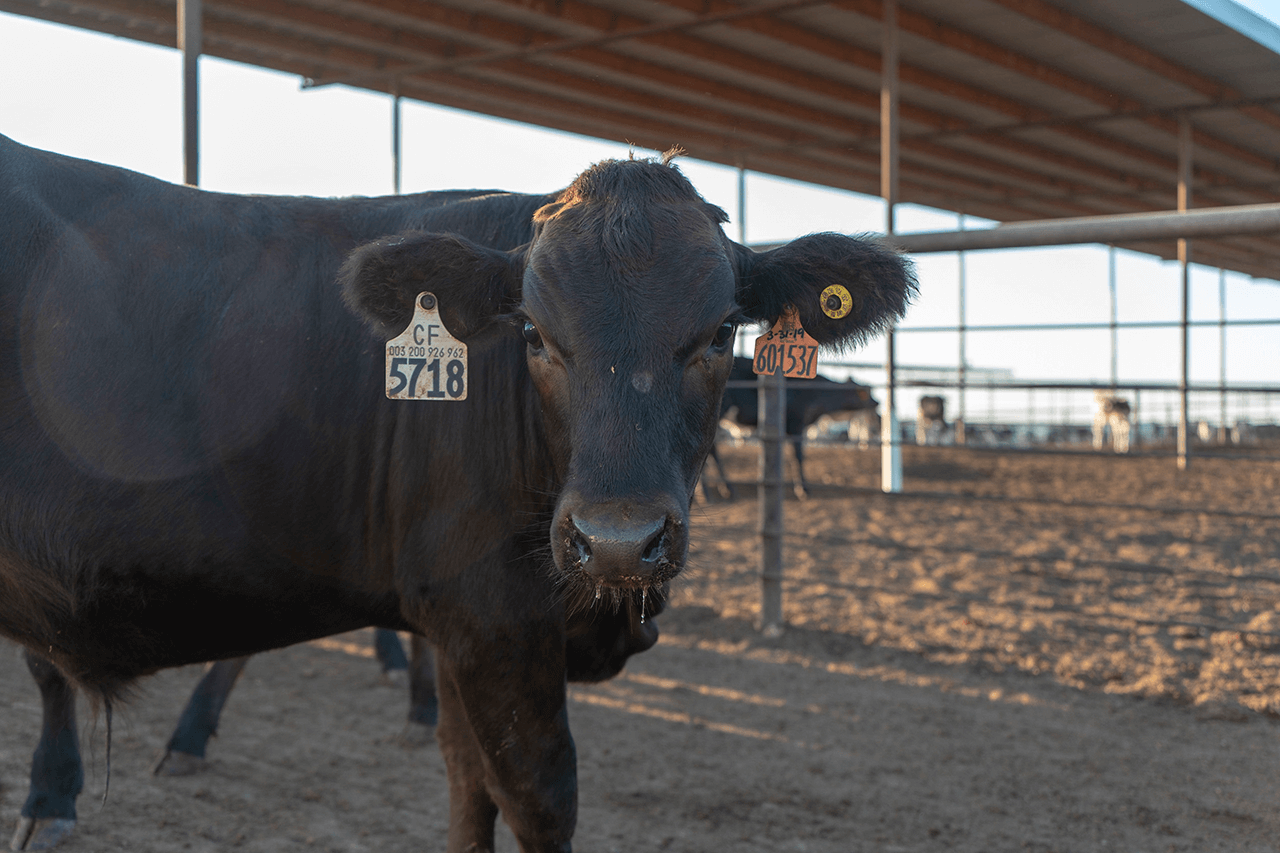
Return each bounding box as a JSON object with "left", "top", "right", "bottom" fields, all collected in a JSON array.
[{"left": 758, "top": 364, "right": 787, "bottom": 637}]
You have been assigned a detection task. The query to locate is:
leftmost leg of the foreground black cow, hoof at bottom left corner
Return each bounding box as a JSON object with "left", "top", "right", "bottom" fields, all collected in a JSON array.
[{"left": 10, "top": 651, "right": 84, "bottom": 850}]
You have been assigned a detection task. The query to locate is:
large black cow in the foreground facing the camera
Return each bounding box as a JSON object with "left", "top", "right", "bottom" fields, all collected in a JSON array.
[{"left": 0, "top": 131, "right": 914, "bottom": 852}]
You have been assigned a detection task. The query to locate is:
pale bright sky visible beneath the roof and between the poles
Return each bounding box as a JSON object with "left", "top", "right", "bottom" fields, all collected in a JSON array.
[{"left": 0, "top": 6, "right": 1280, "bottom": 423}]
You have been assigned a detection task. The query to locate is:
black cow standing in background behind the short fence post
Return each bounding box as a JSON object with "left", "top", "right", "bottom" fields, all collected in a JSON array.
[{"left": 710, "top": 356, "right": 877, "bottom": 497}]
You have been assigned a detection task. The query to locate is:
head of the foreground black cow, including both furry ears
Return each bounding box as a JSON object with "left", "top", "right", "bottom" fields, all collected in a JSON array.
[{"left": 342, "top": 159, "right": 914, "bottom": 593}]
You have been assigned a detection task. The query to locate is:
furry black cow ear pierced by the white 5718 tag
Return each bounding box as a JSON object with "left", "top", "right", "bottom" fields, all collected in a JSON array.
[{"left": 338, "top": 232, "right": 525, "bottom": 341}]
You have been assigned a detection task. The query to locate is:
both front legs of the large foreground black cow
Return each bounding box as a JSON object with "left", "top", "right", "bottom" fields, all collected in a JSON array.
[{"left": 436, "top": 634, "right": 577, "bottom": 853}]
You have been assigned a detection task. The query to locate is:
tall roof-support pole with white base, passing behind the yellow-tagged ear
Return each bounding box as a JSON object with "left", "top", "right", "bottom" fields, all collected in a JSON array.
[{"left": 881, "top": 0, "right": 902, "bottom": 492}]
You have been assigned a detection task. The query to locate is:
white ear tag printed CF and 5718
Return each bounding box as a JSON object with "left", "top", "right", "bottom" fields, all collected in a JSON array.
[{"left": 387, "top": 292, "right": 467, "bottom": 400}]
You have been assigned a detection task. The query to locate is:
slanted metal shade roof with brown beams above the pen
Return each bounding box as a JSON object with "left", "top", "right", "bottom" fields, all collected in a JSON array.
[{"left": 10, "top": 0, "right": 1280, "bottom": 278}]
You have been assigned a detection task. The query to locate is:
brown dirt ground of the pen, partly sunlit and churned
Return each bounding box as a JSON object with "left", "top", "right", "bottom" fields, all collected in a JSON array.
[{"left": 0, "top": 447, "right": 1280, "bottom": 853}]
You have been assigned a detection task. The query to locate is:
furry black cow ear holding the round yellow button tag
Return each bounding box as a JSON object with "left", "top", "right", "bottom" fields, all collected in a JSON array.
[{"left": 737, "top": 233, "right": 916, "bottom": 348}]
